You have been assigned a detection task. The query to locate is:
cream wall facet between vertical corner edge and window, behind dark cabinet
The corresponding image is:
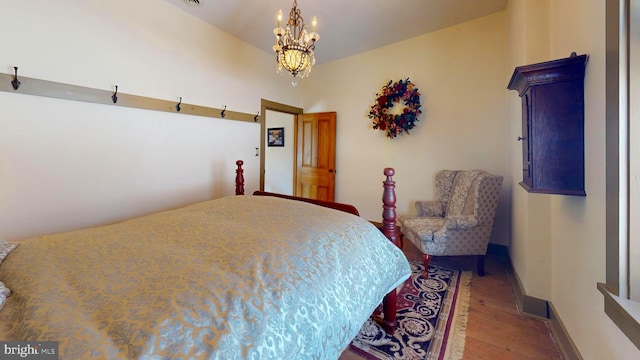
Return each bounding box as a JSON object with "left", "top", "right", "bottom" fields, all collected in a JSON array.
[{"left": 550, "top": 0, "right": 640, "bottom": 359}]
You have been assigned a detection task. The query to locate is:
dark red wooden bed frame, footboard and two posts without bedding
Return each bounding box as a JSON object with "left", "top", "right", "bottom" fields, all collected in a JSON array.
[{"left": 236, "top": 160, "right": 400, "bottom": 335}]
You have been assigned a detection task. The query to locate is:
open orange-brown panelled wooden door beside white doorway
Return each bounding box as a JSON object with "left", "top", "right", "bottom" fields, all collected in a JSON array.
[{"left": 295, "top": 112, "right": 336, "bottom": 201}]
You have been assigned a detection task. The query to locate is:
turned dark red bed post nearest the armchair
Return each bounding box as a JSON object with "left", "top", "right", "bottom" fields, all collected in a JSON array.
[{"left": 382, "top": 168, "right": 400, "bottom": 335}]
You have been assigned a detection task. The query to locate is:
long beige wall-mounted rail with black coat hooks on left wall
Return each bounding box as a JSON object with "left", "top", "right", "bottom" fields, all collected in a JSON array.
[{"left": 0, "top": 69, "right": 257, "bottom": 122}]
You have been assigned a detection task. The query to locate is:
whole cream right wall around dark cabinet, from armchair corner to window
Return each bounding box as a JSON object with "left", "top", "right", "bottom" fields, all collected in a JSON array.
[{"left": 507, "top": 0, "right": 640, "bottom": 360}]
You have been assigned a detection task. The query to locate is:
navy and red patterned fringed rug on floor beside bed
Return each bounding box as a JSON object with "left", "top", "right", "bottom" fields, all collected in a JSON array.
[{"left": 349, "top": 260, "right": 471, "bottom": 360}]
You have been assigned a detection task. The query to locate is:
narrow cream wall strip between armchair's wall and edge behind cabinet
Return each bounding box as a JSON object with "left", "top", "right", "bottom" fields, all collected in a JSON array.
[{"left": 507, "top": 0, "right": 556, "bottom": 306}]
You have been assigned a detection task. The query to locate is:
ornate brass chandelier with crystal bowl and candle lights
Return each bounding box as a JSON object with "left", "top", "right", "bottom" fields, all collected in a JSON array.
[{"left": 273, "top": 0, "right": 320, "bottom": 86}]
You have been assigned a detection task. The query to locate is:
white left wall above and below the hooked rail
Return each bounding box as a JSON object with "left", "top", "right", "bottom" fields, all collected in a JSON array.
[{"left": 0, "top": 0, "right": 301, "bottom": 240}]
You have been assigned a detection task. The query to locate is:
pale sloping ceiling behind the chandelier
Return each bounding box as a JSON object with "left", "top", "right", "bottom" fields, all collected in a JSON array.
[{"left": 165, "top": 0, "right": 507, "bottom": 64}]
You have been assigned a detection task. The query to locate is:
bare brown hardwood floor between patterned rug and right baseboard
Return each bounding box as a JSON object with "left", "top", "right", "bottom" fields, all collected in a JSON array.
[{"left": 340, "top": 241, "right": 562, "bottom": 360}]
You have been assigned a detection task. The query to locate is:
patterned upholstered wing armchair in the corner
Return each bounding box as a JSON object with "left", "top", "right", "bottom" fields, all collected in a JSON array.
[{"left": 398, "top": 170, "right": 502, "bottom": 276}]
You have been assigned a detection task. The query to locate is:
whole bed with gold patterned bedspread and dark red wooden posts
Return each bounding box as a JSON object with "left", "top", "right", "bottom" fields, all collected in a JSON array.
[{"left": 0, "top": 161, "right": 411, "bottom": 359}]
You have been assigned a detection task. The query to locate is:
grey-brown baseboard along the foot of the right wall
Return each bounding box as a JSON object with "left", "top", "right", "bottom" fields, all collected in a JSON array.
[{"left": 507, "top": 255, "right": 583, "bottom": 360}]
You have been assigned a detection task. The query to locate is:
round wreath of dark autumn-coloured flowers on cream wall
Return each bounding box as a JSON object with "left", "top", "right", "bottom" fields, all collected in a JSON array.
[{"left": 369, "top": 78, "right": 422, "bottom": 139}]
